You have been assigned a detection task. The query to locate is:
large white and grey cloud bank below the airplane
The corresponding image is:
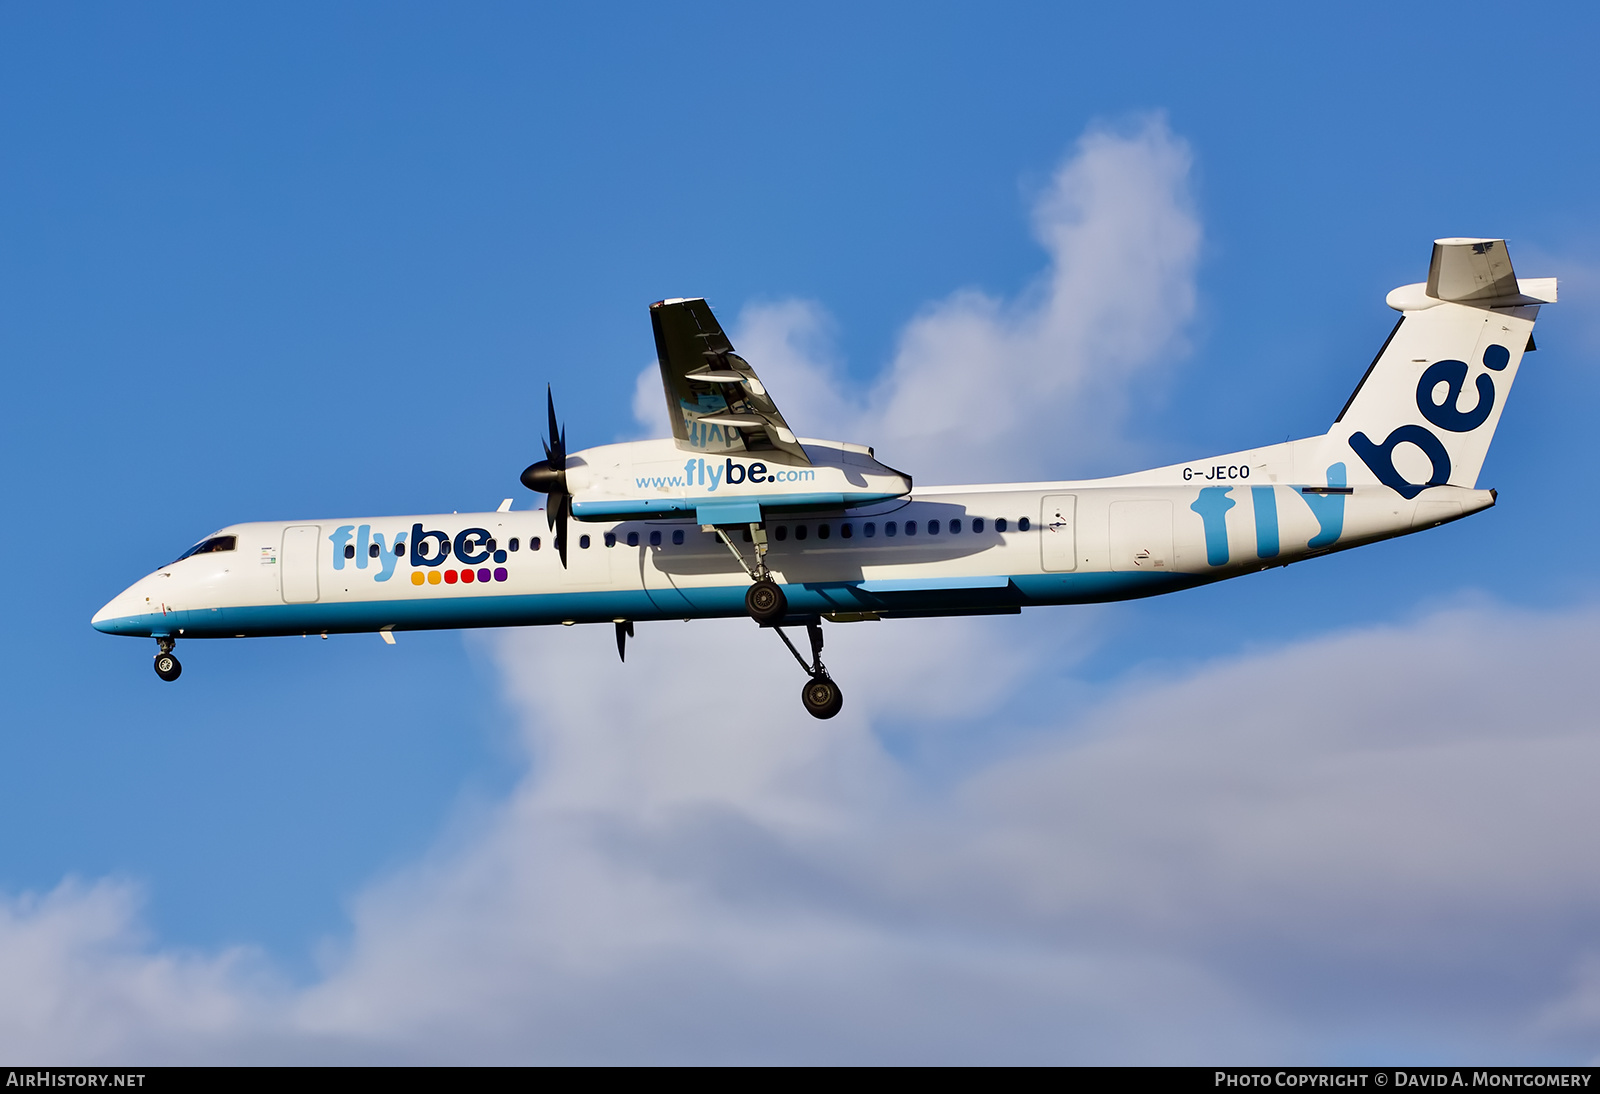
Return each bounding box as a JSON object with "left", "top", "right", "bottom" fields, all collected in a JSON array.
[{"left": 9, "top": 608, "right": 1600, "bottom": 1060}]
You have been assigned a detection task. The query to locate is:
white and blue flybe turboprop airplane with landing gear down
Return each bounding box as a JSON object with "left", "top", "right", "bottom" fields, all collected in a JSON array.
[{"left": 93, "top": 238, "right": 1557, "bottom": 718}]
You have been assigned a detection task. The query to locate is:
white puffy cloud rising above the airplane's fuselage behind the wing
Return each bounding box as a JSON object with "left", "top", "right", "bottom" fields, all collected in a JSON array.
[{"left": 634, "top": 117, "right": 1200, "bottom": 483}]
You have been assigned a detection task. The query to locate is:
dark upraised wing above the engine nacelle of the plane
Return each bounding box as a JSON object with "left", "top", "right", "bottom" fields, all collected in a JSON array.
[{"left": 650, "top": 299, "right": 811, "bottom": 464}]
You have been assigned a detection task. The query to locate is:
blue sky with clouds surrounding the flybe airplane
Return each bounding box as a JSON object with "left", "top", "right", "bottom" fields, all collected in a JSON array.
[{"left": 0, "top": 5, "right": 1600, "bottom": 1062}]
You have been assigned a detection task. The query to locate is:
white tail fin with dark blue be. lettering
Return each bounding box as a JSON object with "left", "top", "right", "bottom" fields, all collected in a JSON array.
[{"left": 1326, "top": 238, "right": 1555, "bottom": 499}]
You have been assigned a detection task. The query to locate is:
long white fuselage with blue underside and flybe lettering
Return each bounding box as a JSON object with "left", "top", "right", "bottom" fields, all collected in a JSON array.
[{"left": 93, "top": 441, "right": 1493, "bottom": 638}]
